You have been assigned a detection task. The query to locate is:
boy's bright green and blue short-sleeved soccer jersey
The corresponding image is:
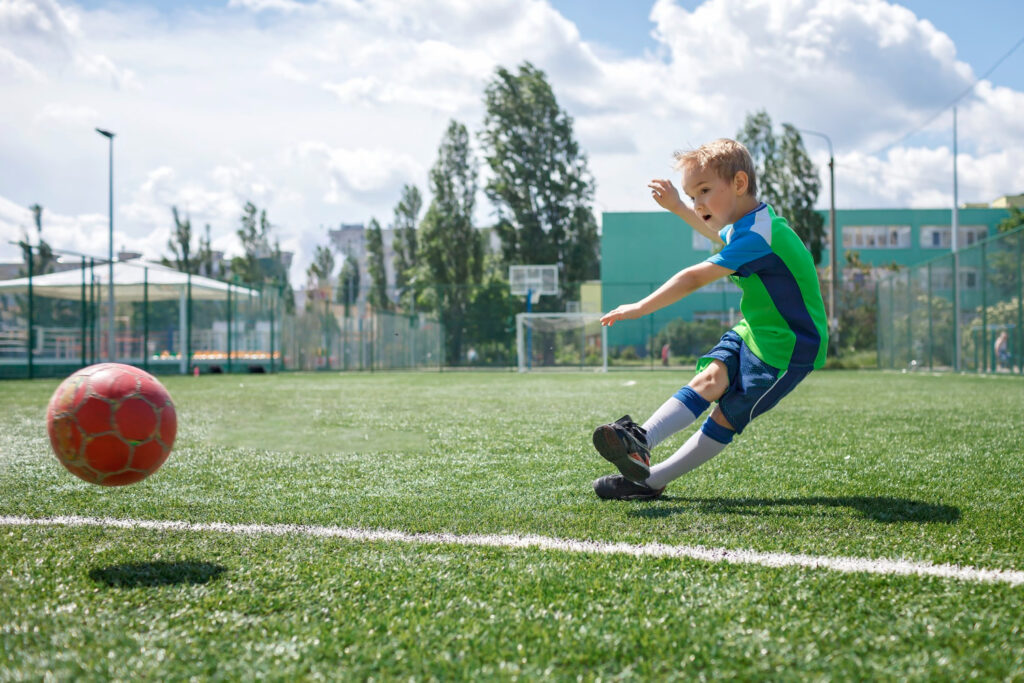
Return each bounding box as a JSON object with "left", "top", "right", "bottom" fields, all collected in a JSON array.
[{"left": 708, "top": 203, "right": 828, "bottom": 370}]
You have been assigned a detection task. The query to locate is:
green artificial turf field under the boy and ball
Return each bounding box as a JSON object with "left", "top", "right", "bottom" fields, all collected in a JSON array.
[{"left": 0, "top": 372, "right": 1024, "bottom": 681}]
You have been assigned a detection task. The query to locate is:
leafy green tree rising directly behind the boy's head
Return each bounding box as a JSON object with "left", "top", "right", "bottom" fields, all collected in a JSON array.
[{"left": 736, "top": 111, "right": 825, "bottom": 263}]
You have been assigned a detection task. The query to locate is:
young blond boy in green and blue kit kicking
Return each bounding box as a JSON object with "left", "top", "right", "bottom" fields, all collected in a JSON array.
[{"left": 594, "top": 138, "right": 828, "bottom": 500}]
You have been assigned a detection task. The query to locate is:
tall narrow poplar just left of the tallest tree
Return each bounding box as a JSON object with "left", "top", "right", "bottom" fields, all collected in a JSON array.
[{"left": 419, "top": 121, "right": 483, "bottom": 362}]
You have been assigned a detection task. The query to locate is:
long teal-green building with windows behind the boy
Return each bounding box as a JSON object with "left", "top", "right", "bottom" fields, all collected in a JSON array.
[{"left": 601, "top": 207, "right": 1010, "bottom": 349}]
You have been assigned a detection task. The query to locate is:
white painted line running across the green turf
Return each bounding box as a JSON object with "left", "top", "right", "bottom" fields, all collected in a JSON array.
[{"left": 6, "top": 516, "right": 1024, "bottom": 586}]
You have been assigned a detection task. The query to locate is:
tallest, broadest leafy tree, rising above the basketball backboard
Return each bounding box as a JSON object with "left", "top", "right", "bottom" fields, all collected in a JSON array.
[{"left": 480, "top": 61, "right": 598, "bottom": 297}]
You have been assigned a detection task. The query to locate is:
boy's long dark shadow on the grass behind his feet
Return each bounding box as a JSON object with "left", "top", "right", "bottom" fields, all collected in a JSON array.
[{"left": 634, "top": 496, "right": 961, "bottom": 524}]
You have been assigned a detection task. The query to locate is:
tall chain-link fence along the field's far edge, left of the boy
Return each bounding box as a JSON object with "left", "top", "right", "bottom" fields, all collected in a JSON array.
[{"left": 0, "top": 252, "right": 761, "bottom": 378}]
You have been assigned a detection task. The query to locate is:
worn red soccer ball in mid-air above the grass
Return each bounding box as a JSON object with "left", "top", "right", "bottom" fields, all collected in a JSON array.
[{"left": 46, "top": 362, "right": 178, "bottom": 486}]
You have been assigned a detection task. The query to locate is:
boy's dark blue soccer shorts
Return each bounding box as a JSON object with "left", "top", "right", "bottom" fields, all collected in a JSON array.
[{"left": 697, "top": 330, "right": 811, "bottom": 434}]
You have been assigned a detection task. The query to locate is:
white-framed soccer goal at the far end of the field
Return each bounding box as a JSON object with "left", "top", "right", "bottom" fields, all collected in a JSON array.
[{"left": 515, "top": 313, "right": 608, "bottom": 373}]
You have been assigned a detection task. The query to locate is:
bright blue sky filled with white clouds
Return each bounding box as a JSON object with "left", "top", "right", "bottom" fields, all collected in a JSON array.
[{"left": 0, "top": 0, "right": 1024, "bottom": 286}]
